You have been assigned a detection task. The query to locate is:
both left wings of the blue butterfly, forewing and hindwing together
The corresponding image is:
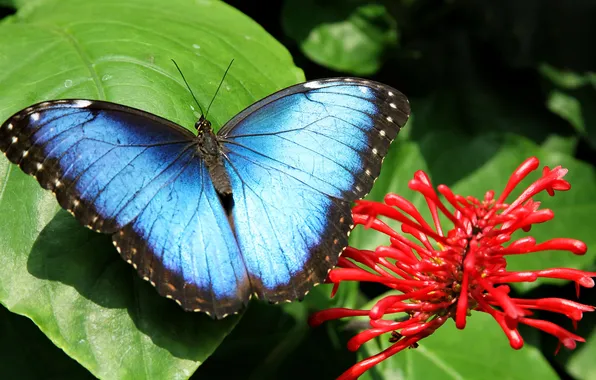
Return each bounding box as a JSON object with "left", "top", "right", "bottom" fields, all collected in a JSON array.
[{"left": 0, "top": 100, "right": 250, "bottom": 317}]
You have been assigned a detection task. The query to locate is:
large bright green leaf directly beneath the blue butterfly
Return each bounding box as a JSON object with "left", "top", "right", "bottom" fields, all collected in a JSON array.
[{"left": 0, "top": 0, "right": 303, "bottom": 379}]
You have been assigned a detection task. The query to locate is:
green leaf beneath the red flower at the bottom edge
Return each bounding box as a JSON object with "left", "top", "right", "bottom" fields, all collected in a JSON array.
[{"left": 359, "top": 298, "right": 558, "bottom": 380}]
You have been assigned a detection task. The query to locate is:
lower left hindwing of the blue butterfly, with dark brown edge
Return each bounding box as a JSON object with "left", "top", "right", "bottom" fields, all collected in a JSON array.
[{"left": 113, "top": 160, "right": 250, "bottom": 318}]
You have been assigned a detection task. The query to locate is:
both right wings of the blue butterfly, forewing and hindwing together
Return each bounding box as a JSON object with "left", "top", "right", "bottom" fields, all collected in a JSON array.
[{"left": 218, "top": 78, "right": 410, "bottom": 302}]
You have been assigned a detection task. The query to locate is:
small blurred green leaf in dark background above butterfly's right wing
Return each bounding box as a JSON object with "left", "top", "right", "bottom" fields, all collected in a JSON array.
[{"left": 282, "top": 0, "right": 398, "bottom": 75}]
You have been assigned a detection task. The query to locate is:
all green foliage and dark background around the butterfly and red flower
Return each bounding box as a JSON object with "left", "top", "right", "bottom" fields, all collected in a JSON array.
[{"left": 0, "top": 0, "right": 596, "bottom": 379}]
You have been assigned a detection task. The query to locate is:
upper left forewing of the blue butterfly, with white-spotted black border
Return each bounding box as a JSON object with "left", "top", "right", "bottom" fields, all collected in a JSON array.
[{"left": 0, "top": 100, "right": 193, "bottom": 233}]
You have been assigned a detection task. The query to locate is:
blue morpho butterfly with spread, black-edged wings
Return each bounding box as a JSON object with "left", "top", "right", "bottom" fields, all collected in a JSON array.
[{"left": 0, "top": 78, "right": 410, "bottom": 318}]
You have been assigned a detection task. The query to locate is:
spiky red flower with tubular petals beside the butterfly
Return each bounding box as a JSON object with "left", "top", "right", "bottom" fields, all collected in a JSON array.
[{"left": 309, "top": 157, "right": 596, "bottom": 379}]
